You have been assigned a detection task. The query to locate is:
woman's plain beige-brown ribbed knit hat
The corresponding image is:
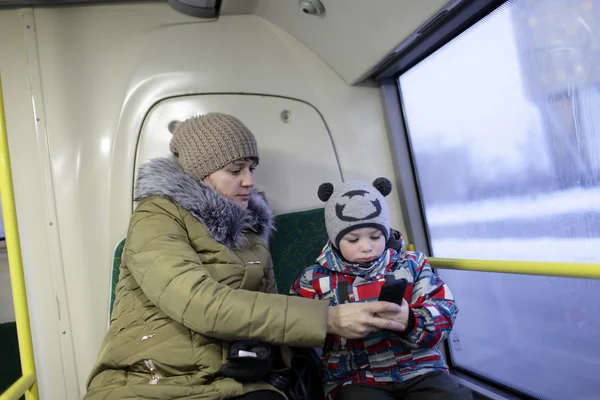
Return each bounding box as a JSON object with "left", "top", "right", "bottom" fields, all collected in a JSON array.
[{"left": 170, "top": 113, "right": 258, "bottom": 181}]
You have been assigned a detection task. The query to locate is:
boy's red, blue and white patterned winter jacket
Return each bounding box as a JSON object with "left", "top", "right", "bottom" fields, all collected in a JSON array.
[{"left": 290, "top": 231, "right": 458, "bottom": 399}]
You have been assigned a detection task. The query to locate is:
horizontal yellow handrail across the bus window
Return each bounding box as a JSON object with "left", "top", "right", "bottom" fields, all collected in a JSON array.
[{"left": 429, "top": 257, "right": 600, "bottom": 279}]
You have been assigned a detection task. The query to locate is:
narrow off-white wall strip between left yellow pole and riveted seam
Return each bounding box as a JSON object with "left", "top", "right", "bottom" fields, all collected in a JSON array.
[{"left": 0, "top": 10, "right": 71, "bottom": 399}]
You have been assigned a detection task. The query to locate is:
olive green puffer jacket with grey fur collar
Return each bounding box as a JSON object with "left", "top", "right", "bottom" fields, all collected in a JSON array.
[{"left": 85, "top": 158, "right": 328, "bottom": 400}]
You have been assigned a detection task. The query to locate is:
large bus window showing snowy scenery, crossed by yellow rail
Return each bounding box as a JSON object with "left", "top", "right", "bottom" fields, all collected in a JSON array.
[{"left": 398, "top": 0, "right": 600, "bottom": 399}]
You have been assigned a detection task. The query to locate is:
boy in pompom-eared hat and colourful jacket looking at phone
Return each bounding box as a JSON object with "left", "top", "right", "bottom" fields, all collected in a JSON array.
[{"left": 291, "top": 178, "right": 471, "bottom": 400}]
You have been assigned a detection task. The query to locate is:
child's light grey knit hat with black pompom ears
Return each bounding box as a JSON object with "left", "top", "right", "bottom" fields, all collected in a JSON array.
[{"left": 318, "top": 178, "right": 392, "bottom": 248}]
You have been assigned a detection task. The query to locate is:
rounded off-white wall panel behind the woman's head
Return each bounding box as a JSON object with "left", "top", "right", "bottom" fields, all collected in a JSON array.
[{"left": 136, "top": 95, "right": 341, "bottom": 214}]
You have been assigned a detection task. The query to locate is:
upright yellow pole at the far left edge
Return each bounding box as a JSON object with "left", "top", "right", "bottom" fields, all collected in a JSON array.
[{"left": 0, "top": 78, "right": 38, "bottom": 400}]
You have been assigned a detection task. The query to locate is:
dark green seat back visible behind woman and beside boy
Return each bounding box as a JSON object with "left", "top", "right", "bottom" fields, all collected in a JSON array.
[{"left": 105, "top": 208, "right": 327, "bottom": 314}]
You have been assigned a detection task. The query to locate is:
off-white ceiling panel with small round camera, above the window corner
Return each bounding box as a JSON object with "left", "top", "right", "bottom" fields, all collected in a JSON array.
[{"left": 255, "top": 0, "right": 449, "bottom": 83}]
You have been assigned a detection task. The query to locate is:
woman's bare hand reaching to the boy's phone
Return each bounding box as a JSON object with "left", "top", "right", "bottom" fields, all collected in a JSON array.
[{"left": 327, "top": 301, "right": 408, "bottom": 339}]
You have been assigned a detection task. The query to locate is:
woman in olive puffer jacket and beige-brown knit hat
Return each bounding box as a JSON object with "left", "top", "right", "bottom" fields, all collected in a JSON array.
[{"left": 85, "top": 113, "right": 401, "bottom": 400}]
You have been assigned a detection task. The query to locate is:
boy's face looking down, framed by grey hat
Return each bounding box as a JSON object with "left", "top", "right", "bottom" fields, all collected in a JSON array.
[{"left": 340, "top": 228, "right": 385, "bottom": 264}]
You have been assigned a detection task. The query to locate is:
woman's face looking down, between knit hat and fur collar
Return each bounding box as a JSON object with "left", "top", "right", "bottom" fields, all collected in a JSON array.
[{"left": 204, "top": 159, "right": 258, "bottom": 210}]
